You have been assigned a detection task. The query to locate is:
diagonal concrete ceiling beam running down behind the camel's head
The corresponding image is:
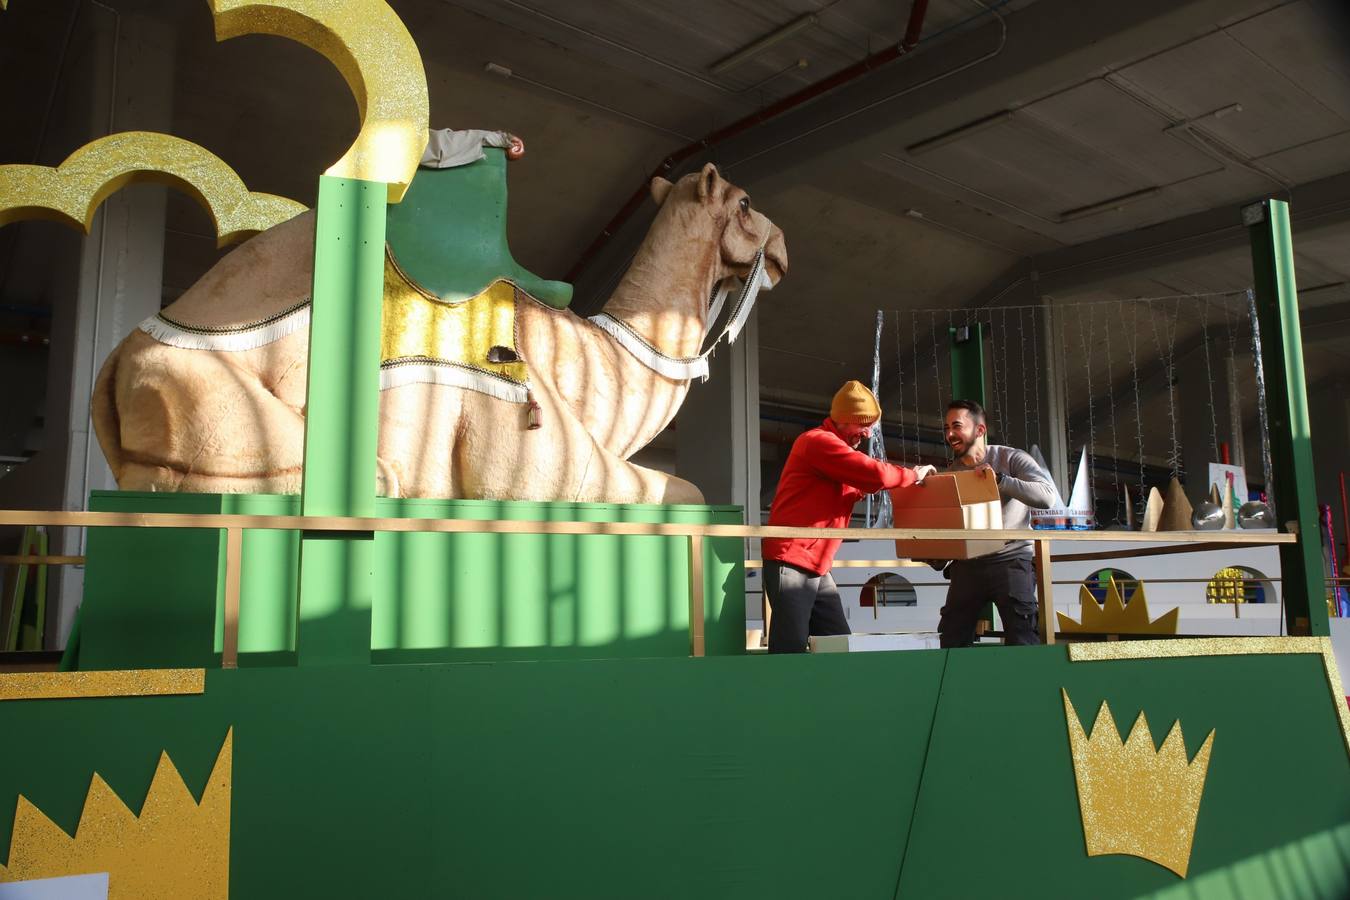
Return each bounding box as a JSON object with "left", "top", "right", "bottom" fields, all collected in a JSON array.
[{"left": 575, "top": 0, "right": 1272, "bottom": 307}]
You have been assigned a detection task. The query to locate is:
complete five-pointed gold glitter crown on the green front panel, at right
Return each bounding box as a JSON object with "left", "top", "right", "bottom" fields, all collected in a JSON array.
[{"left": 1062, "top": 691, "right": 1214, "bottom": 878}]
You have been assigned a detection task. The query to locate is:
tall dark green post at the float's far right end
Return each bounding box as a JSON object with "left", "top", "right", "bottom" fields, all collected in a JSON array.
[{"left": 1242, "top": 200, "right": 1331, "bottom": 636}]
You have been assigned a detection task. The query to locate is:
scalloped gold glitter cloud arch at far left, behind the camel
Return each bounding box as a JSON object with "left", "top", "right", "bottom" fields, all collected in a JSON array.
[{"left": 0, "top": 131, "right": 305, "bottom": 247}]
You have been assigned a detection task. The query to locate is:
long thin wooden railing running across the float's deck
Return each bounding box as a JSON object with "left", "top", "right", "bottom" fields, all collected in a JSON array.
[{"left": 0, "top": 510, "right": 1297, "bottom": 668}]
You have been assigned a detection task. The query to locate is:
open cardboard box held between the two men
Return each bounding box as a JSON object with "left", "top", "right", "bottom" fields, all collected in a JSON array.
[{"left": 891, "top": 470, "right": 1003, "bottom": 560}]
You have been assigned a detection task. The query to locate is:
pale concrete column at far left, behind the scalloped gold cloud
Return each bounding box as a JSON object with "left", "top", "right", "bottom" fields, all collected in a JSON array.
[{"left": 45, "top": 4, "right": 174, "bottom": 646}]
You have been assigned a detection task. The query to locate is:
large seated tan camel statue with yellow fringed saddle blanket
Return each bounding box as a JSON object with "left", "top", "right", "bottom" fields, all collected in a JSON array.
[{"left": 92, "top": 158, "right": 787, "bottom": 503}]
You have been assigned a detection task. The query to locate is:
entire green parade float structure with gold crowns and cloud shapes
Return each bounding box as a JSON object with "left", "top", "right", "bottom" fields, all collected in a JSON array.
[{"left": 0, "top": 0, "right": 1350, "bottom": 899}]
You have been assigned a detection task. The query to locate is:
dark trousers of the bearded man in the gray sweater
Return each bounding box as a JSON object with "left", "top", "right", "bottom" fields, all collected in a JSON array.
[{"left": 937, "top": 557, "right": 1041, "bottom": 646}]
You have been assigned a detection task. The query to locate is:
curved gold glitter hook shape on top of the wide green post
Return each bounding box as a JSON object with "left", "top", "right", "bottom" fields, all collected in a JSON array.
[{"left": 211, "top": 0, "right": 431, "bottom": 202}]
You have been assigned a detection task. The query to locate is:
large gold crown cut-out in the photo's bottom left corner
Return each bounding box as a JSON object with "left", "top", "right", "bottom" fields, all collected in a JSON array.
[{"left": 0, "top": 729, "right": 234, "bottom": 900}]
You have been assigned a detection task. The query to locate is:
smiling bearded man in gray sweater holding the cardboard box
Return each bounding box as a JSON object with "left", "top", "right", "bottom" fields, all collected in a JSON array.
[{"left": 937, "top": 399, "right": 1054, "bottom": 646}]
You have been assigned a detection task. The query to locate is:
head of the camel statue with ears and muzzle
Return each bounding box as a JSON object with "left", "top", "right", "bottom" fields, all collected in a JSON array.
[{"left": 652, "top": 163, "right": 787, "bottom": 285}]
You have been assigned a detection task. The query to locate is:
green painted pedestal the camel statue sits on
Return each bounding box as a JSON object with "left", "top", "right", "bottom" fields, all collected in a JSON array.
[{"left": 80, "top": 491, "right": 745, "bottom": 669}]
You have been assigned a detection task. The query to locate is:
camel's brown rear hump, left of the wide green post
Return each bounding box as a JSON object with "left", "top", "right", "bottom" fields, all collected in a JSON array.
[{"left": 162, "top": 210, "right": 315, "bottom": 329}]
